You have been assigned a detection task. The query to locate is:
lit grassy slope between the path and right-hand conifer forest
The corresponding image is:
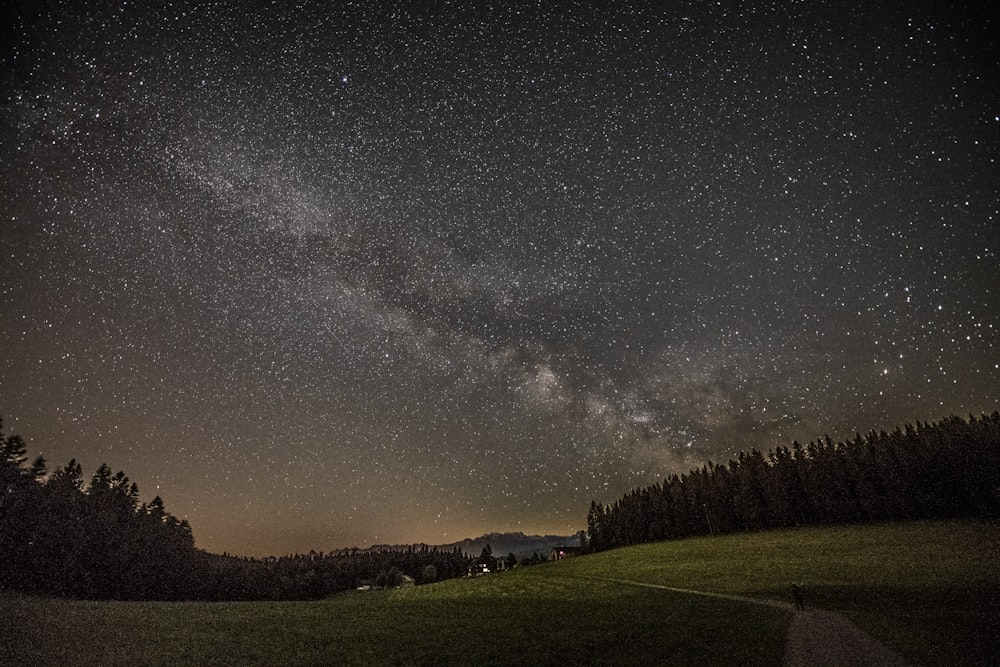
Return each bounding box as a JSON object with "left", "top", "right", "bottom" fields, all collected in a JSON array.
[{"left": 562, "top": 521, "right": 1000, "bottom": 665}]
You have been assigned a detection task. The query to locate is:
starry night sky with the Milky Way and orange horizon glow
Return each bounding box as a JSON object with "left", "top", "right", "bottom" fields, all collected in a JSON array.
[{"left": 0, "top": 0, "right": 1000, "bottom": 555}]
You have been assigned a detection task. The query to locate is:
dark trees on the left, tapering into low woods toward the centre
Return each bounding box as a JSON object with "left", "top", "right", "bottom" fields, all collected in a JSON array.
[{"left": 0, "top": 420, "right": 476, "bottom": 600}]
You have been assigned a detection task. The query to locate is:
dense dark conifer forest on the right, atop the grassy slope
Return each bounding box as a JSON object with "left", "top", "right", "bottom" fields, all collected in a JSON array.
[{"left": 587, "top": 412, "right": 1000, "bottom": 551}]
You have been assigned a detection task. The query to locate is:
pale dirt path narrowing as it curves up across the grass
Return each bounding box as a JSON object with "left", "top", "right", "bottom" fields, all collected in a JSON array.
[{"left": 596, "top": 579, "right": 909, "bottom": 667}]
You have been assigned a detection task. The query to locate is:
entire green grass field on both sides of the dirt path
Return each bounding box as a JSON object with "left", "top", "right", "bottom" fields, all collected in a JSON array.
[{"left": 0, "top": 521, "right": 1000, "bottom": 665}]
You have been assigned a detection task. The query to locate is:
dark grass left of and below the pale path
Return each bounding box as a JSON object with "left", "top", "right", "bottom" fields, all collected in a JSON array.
[{"left": 0, "top": 567, "right": 788, "bottom": 665}]
